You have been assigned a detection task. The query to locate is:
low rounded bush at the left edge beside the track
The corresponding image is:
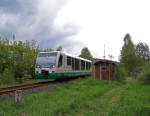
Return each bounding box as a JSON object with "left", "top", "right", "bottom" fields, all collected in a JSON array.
[{"left": 0, "top": 69, "right": 15, "bottom": 84}]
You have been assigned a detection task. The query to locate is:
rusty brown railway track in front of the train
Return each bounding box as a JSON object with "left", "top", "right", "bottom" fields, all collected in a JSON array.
[{"left": 0, "top": 82, "right": 48, "bottom": 96}]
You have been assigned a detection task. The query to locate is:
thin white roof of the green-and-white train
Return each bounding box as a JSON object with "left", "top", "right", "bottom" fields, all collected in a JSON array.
[{"left": 39, "top": 51, "right": 92, "bottom": 62}]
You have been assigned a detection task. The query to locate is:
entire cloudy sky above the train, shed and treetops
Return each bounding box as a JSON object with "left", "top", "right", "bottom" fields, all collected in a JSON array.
[{"left": 0, "top": 0, "right": 150, "bottom": 60}]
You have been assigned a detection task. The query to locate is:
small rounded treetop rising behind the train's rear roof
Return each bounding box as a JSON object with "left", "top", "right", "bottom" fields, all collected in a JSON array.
[{"left": 79, "top": 47, "right": 93, "bottom": 60}]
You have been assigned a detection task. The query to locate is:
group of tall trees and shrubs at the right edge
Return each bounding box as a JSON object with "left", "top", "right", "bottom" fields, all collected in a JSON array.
[{"left": 120, "top": 34, "right": 150, "bottom": 83}]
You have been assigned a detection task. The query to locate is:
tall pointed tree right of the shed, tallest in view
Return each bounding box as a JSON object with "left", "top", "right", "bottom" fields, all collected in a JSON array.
[{"left": 120, "top": 34, "right": 138, "bottom": 76}]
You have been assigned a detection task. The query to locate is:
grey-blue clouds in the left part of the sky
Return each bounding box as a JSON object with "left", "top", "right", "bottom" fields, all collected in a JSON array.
[{"left": 0, "top": 0, "right": 78, "bottom": 48}]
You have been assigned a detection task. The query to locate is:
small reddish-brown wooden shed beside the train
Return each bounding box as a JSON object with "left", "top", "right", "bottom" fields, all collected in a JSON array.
[{"left": 94, "top": 59, "right": 117, "bottom": 80}]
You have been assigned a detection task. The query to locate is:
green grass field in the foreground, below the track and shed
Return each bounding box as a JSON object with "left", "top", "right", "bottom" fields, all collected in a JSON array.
[{"left": 0, "top": 78, "right": 150, "bottom": 116}]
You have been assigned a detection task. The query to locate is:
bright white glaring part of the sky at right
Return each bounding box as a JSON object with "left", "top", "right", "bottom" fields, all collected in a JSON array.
[{"left": 56, "top": 0, "right": 150, "bottom": 60}]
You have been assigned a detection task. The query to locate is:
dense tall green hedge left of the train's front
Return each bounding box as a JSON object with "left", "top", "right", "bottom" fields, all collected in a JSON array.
[{"left": 0, "top": 38, "right": 37, "bottom": 84}]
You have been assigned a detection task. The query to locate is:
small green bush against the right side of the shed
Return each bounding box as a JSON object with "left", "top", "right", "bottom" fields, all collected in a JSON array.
[{"left": 116, "top": 64, "right": 127, "bottom": 82}]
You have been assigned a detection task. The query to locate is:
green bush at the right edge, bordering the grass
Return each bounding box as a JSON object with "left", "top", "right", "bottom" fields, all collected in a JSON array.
[{"left": 138, "top": 65, "right": 150, "bottom": 84}]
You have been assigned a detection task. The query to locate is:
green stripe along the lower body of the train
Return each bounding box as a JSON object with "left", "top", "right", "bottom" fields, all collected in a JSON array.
[{"left": 35, "top": 72, "right": 91, "bottom": 79}]
